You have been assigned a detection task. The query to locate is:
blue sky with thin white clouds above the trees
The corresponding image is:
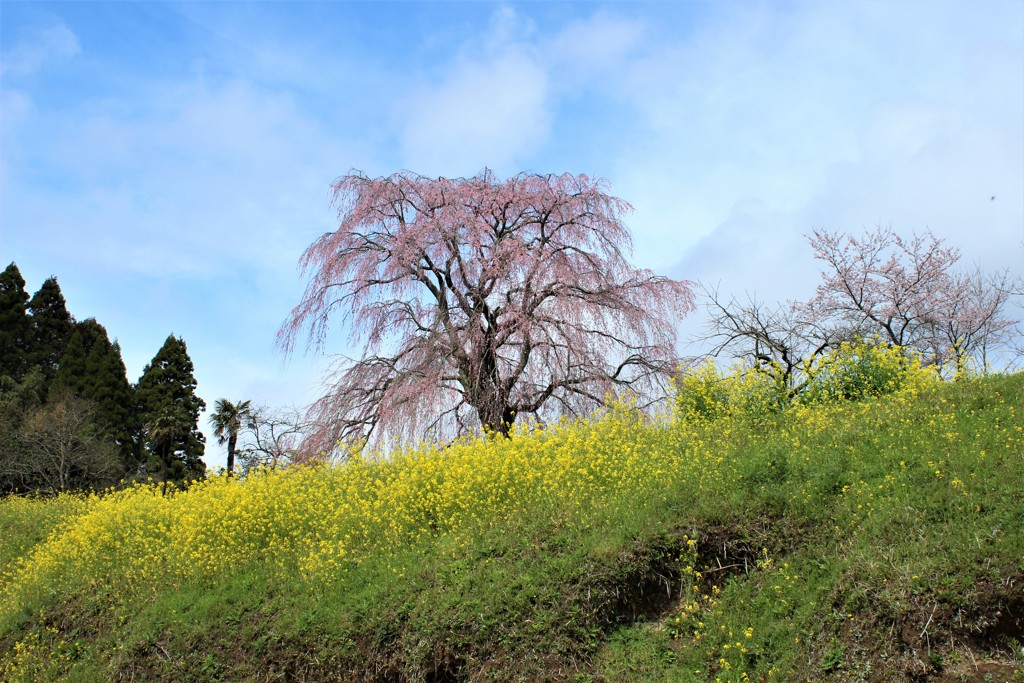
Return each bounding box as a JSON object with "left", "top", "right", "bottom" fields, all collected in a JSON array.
[{"left": 0, "top": 0, "right": 1024, "bottom": 465}]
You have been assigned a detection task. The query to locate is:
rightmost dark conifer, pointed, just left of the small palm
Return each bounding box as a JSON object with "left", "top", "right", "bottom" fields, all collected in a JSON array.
[{"left": 135, "top": 335, "right": 206, "bottom": 481}]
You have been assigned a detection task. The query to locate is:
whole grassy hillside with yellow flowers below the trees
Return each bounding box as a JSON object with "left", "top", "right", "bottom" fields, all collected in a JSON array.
[{"left": 0, "top": 375, "right": 1024, "bottom": 681}]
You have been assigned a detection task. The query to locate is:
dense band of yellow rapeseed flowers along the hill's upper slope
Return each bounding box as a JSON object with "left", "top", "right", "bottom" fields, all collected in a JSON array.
[{"left": 0, "top": 339, "right": 942, "bottom": 616}]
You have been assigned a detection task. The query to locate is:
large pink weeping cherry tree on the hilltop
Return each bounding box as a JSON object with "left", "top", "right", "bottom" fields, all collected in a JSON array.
[{"left": 279, "top": 170, "right": 693, "bottom": 453}]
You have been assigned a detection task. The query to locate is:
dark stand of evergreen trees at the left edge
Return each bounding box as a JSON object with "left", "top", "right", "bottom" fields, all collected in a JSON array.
[{"left": 0, "top": 263, "right": 206, "bottom": 495}]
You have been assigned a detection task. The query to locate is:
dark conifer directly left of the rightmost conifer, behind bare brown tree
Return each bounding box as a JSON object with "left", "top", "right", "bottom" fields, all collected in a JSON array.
[{"left": 50, "top": 317, "right": 139, "bottom": 475}]
